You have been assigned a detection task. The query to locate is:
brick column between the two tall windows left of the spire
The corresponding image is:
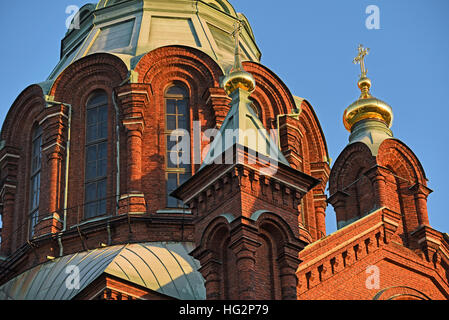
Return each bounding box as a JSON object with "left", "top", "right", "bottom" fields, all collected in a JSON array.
[{"left": 117, "top": 84, "right": 149, "bottom": 214}]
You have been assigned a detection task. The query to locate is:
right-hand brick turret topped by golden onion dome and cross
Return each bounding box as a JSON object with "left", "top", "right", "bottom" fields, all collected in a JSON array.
[{"left": 329, "top": 45, "right": 432, "bottom": 252}]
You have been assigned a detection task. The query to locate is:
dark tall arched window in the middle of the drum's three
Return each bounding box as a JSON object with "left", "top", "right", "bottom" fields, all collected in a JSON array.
[{"left": 84, "top": 92, "right": 108, "bottom": 219}]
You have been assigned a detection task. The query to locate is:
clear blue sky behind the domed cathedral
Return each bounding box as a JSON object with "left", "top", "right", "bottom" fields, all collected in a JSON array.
[{"left": 0, "top": 0, "right": 449, "bottom": 232}]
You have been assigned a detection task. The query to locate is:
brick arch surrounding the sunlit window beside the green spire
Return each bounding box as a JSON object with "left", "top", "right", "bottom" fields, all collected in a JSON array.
[{"left": 122, "top": 46, "right": 229, "bottom": 212}]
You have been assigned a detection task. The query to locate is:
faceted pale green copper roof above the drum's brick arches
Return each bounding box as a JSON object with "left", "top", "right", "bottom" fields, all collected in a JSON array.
[{"left": 44, "top": 0, "right": 261, "bottom": 87}]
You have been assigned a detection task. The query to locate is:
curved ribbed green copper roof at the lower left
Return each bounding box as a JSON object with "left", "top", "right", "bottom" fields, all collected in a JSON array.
[{"left": 0, "top": 242, "right": 206, "bottom": 300}]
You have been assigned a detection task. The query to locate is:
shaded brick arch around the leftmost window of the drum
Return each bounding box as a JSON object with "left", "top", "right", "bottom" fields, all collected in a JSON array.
[{"left": 0, "top": 85, "right": 46, "bottom": 253}]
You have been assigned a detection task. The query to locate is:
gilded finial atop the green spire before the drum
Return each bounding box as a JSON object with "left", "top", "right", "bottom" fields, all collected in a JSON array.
[{"left": 223, "top": 20, "right": 256, "bottom": 95}]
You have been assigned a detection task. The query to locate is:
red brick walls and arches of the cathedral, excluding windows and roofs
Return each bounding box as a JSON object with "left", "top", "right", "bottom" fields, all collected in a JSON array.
[{"left": 0, "top": 46, "right": 449, "bottom": 299}]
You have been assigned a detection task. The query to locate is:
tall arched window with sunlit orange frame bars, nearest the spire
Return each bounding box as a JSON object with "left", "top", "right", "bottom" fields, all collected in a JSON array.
[{"left": 165, "top": 85, "right": 192, "bottom": 208}]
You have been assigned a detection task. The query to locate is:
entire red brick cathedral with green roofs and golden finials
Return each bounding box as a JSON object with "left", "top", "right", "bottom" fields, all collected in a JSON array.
[{"left": 0, "top": 0, "right": 449, "bottom": 300}]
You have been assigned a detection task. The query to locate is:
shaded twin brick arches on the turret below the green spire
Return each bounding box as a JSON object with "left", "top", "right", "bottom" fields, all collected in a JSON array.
[{"left": 192, "top": 210, "right": 305, "bottom": 299}]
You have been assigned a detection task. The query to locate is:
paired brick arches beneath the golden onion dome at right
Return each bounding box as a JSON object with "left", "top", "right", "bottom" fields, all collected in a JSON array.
[{"left": 329, "top": 139, "right": 432, "bottom": 239}]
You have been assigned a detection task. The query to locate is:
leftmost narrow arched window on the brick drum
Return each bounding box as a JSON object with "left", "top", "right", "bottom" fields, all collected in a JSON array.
[{"left": 29, "top": 127, "right": 42, "bottom": 238}]
